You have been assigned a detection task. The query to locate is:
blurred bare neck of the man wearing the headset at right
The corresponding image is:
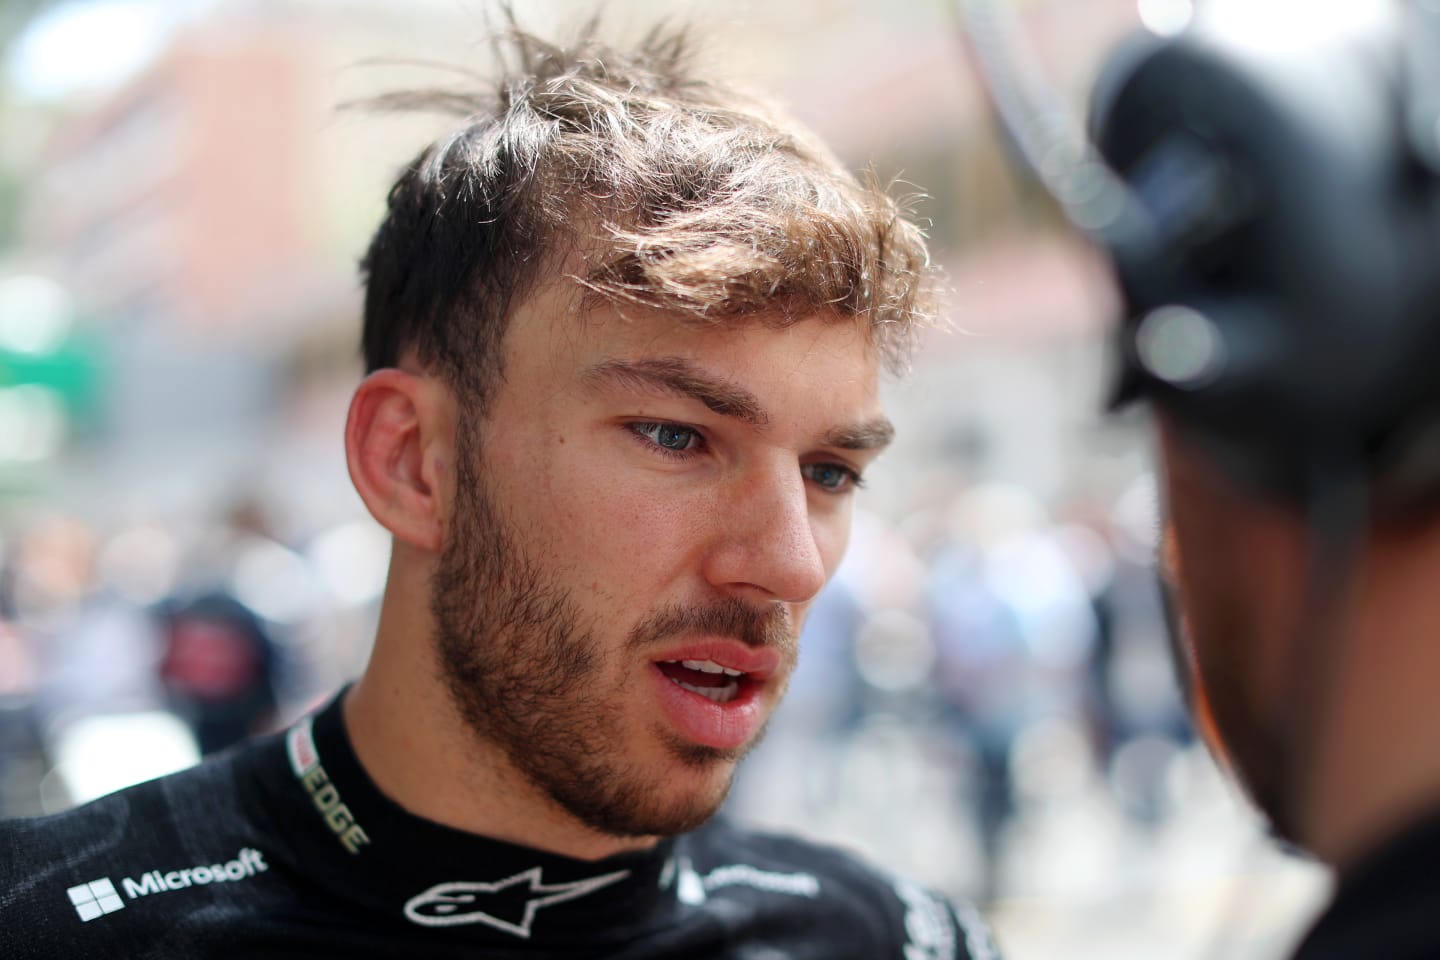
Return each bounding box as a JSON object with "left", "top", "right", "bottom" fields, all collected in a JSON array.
[{"left": 1305, "top": 537, "right": 1440, "bottom": 872}]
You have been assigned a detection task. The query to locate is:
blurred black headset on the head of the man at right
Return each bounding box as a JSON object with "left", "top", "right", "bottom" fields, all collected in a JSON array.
[{"left": 1092, "top": 4, "right": 1440, "bottom": 515}]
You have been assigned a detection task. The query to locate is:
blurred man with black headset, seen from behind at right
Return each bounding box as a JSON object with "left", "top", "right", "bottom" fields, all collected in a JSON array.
[{"left": 1097, "top": 4, "right": 1440, "bottom": 960}]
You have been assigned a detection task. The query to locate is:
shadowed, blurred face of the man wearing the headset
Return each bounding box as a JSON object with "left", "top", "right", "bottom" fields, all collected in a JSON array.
[{"left": 1161, "top": 419, "right": 1305, "bottom": 842}]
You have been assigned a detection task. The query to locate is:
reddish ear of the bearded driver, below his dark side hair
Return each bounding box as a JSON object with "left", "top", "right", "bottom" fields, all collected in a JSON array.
[{"left": 346, "top": 368, "right": 455, "bottom": 553}]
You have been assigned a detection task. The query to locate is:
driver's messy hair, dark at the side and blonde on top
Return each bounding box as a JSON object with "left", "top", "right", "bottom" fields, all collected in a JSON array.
[{"left": 361, "top": 19, "right": 932, "bottom": 406}]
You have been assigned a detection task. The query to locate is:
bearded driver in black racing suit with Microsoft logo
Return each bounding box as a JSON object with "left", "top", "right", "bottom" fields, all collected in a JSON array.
[{"left": 0, "top": 15, "right": 995, "bottom": 960}]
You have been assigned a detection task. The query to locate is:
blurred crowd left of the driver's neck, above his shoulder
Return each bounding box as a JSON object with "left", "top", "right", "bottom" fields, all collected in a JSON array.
[{"left": 0, "top": 502, "right": 389, "bottom": 816}]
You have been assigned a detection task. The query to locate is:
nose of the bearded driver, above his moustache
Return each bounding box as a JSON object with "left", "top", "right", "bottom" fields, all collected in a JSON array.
[{"left": 706, "top": 463, "right": 828, "bottom": 603}]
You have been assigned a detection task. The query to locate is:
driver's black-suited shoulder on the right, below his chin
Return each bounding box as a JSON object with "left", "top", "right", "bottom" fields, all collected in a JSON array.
[{"left": 681, "top": 820, "right": 999, "bottom": 960}]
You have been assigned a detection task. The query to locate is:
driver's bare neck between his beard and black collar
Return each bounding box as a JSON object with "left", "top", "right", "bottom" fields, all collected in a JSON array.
[{"left": 344, "top": 544, "right": 657, "bottom": 861}]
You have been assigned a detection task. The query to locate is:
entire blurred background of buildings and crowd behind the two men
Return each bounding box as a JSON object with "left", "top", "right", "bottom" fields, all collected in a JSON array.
[{"left": 0, "top": 0, "right": 1326, "bottom": 960}]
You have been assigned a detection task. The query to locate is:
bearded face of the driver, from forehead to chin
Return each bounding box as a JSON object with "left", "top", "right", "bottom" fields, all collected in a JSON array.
[{"left": 432, "top": 291, "right": 890, "bottom": 836}]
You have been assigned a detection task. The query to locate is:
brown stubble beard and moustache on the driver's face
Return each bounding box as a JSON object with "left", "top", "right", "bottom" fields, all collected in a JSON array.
[{"left": 431, "top": 422, "right": 795, "bottom": 838}]
